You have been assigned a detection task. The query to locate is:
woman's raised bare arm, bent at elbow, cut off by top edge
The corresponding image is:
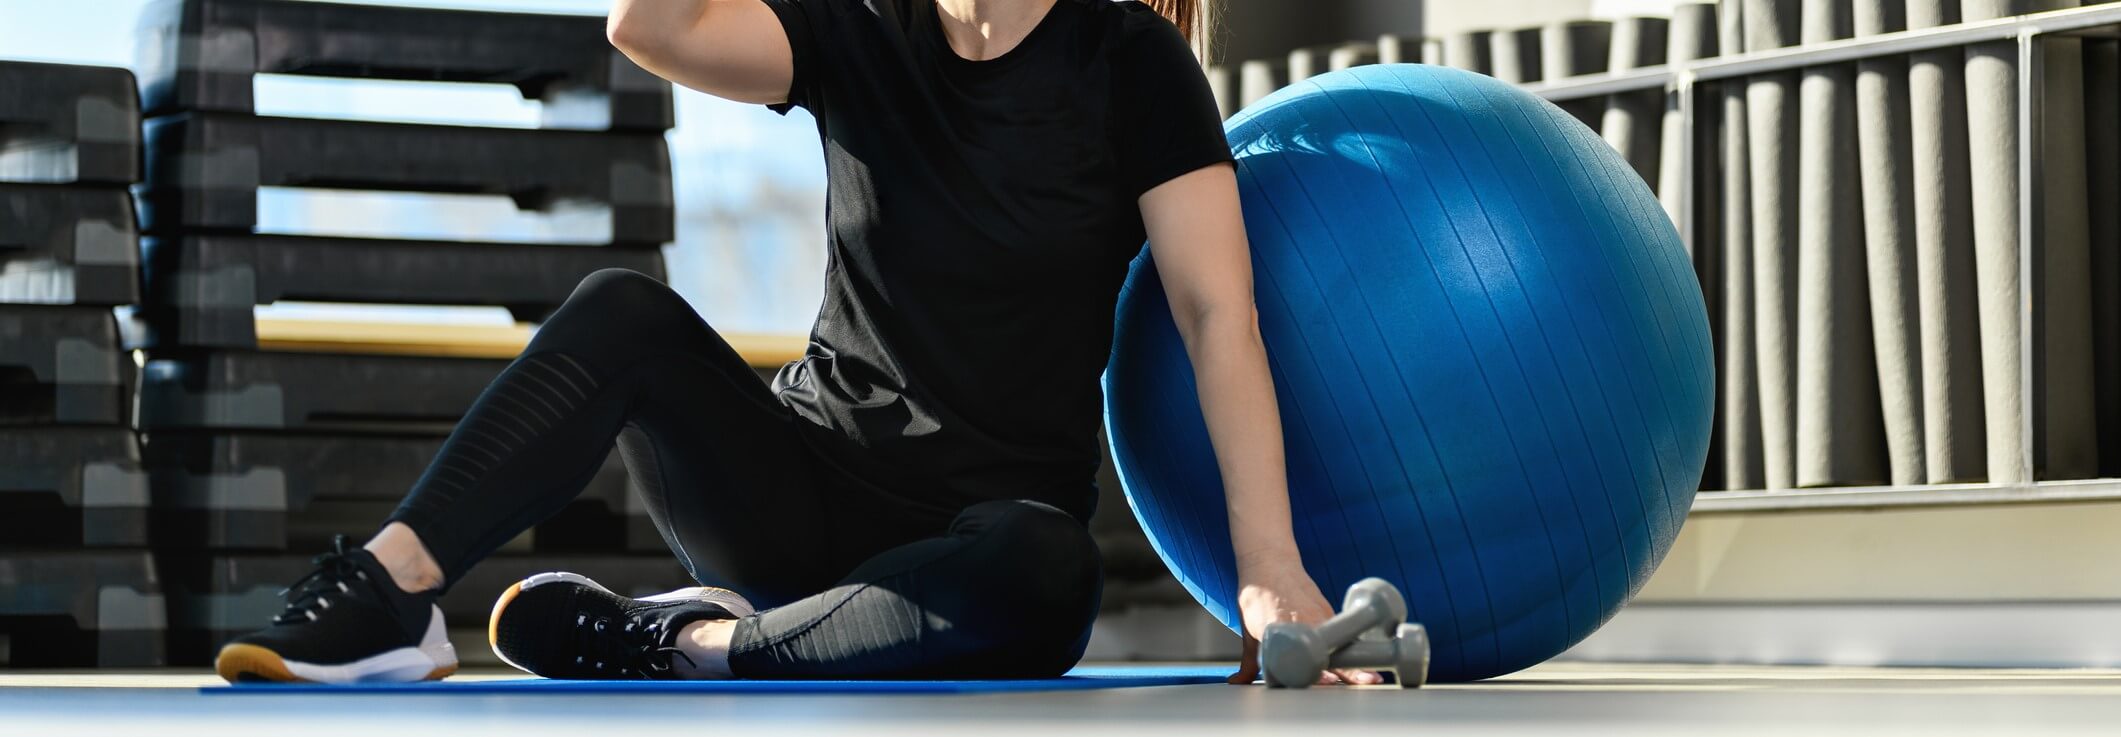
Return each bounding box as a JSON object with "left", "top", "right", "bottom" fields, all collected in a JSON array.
[{"left": 604, "top": 0, "right": 795, "bottom": 104}]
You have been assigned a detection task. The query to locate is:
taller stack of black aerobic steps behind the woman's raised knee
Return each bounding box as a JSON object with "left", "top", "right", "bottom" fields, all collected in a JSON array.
[{"left": 136, "top": 0, "right": 687, "bottom": 663}]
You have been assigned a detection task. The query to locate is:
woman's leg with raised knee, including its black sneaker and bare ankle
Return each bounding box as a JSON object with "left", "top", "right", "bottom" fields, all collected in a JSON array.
[{"left": 216, "top": 272, "right": 846, "bottom": 682}]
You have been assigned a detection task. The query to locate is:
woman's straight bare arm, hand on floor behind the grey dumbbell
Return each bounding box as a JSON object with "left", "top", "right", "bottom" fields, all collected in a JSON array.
[{"left": 1141, "top": 164, "right": 1379, "bottom": 684}]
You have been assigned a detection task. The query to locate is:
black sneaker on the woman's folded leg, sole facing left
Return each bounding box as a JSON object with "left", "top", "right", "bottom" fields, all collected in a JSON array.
[{"left": 486, "top": 573, "right": 753, "bottom": 680}]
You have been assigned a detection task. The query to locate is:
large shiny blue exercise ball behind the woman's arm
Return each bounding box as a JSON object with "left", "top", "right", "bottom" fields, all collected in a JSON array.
[{"left": 1105, "top": 64, "right": 1714, "bottom": 682}]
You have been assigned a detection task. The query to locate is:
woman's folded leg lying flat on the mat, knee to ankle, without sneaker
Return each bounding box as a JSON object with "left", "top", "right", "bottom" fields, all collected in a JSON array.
[{"left": 704, "top": 501, "right": 1103, "bottom": 678}]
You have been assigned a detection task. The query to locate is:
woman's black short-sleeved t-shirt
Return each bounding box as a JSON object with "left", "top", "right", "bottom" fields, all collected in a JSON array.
[{"left": 766, "top": 0, "right": 1230, "bottom": 518}]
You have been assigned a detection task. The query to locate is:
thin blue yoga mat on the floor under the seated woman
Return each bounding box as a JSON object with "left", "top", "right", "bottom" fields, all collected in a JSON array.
[{"left": 199, "top": 665, "right": 1232, "bottom": 695}]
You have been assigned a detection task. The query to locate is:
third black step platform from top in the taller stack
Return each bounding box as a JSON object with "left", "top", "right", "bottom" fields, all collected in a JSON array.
[{"left": 140, "top": 236, "right": 664, "bottom": 348}]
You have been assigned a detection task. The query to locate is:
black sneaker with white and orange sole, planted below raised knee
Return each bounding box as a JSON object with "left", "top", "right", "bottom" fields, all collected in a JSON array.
[{"left": 214, "top": 535, "right": 456, "bottom": 684}]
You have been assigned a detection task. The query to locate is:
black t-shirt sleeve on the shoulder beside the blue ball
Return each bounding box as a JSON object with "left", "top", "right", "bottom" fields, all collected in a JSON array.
[{"left": 1114, "top": 11, "right": 1230, "bottom": 198}]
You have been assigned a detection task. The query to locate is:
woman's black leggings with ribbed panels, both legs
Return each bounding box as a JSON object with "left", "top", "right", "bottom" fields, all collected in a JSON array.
[{"left": 390, "top": 270, "right": 1101, "bottom": 678}]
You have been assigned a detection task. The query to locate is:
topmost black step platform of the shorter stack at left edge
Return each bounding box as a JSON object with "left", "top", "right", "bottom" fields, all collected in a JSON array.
[{"left": 0, "top": 62, "right": 140, "bottom": 185}]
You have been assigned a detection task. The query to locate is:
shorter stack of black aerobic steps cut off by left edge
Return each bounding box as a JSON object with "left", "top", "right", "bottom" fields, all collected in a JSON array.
[{"left": 0, "top": 62, "right": 163, "bottom": 667}]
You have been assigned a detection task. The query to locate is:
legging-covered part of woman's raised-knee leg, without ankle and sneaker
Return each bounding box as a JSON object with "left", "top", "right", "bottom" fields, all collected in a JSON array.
[{"left": 378, "top": 270, "right": 838, "bottom": 595}]
